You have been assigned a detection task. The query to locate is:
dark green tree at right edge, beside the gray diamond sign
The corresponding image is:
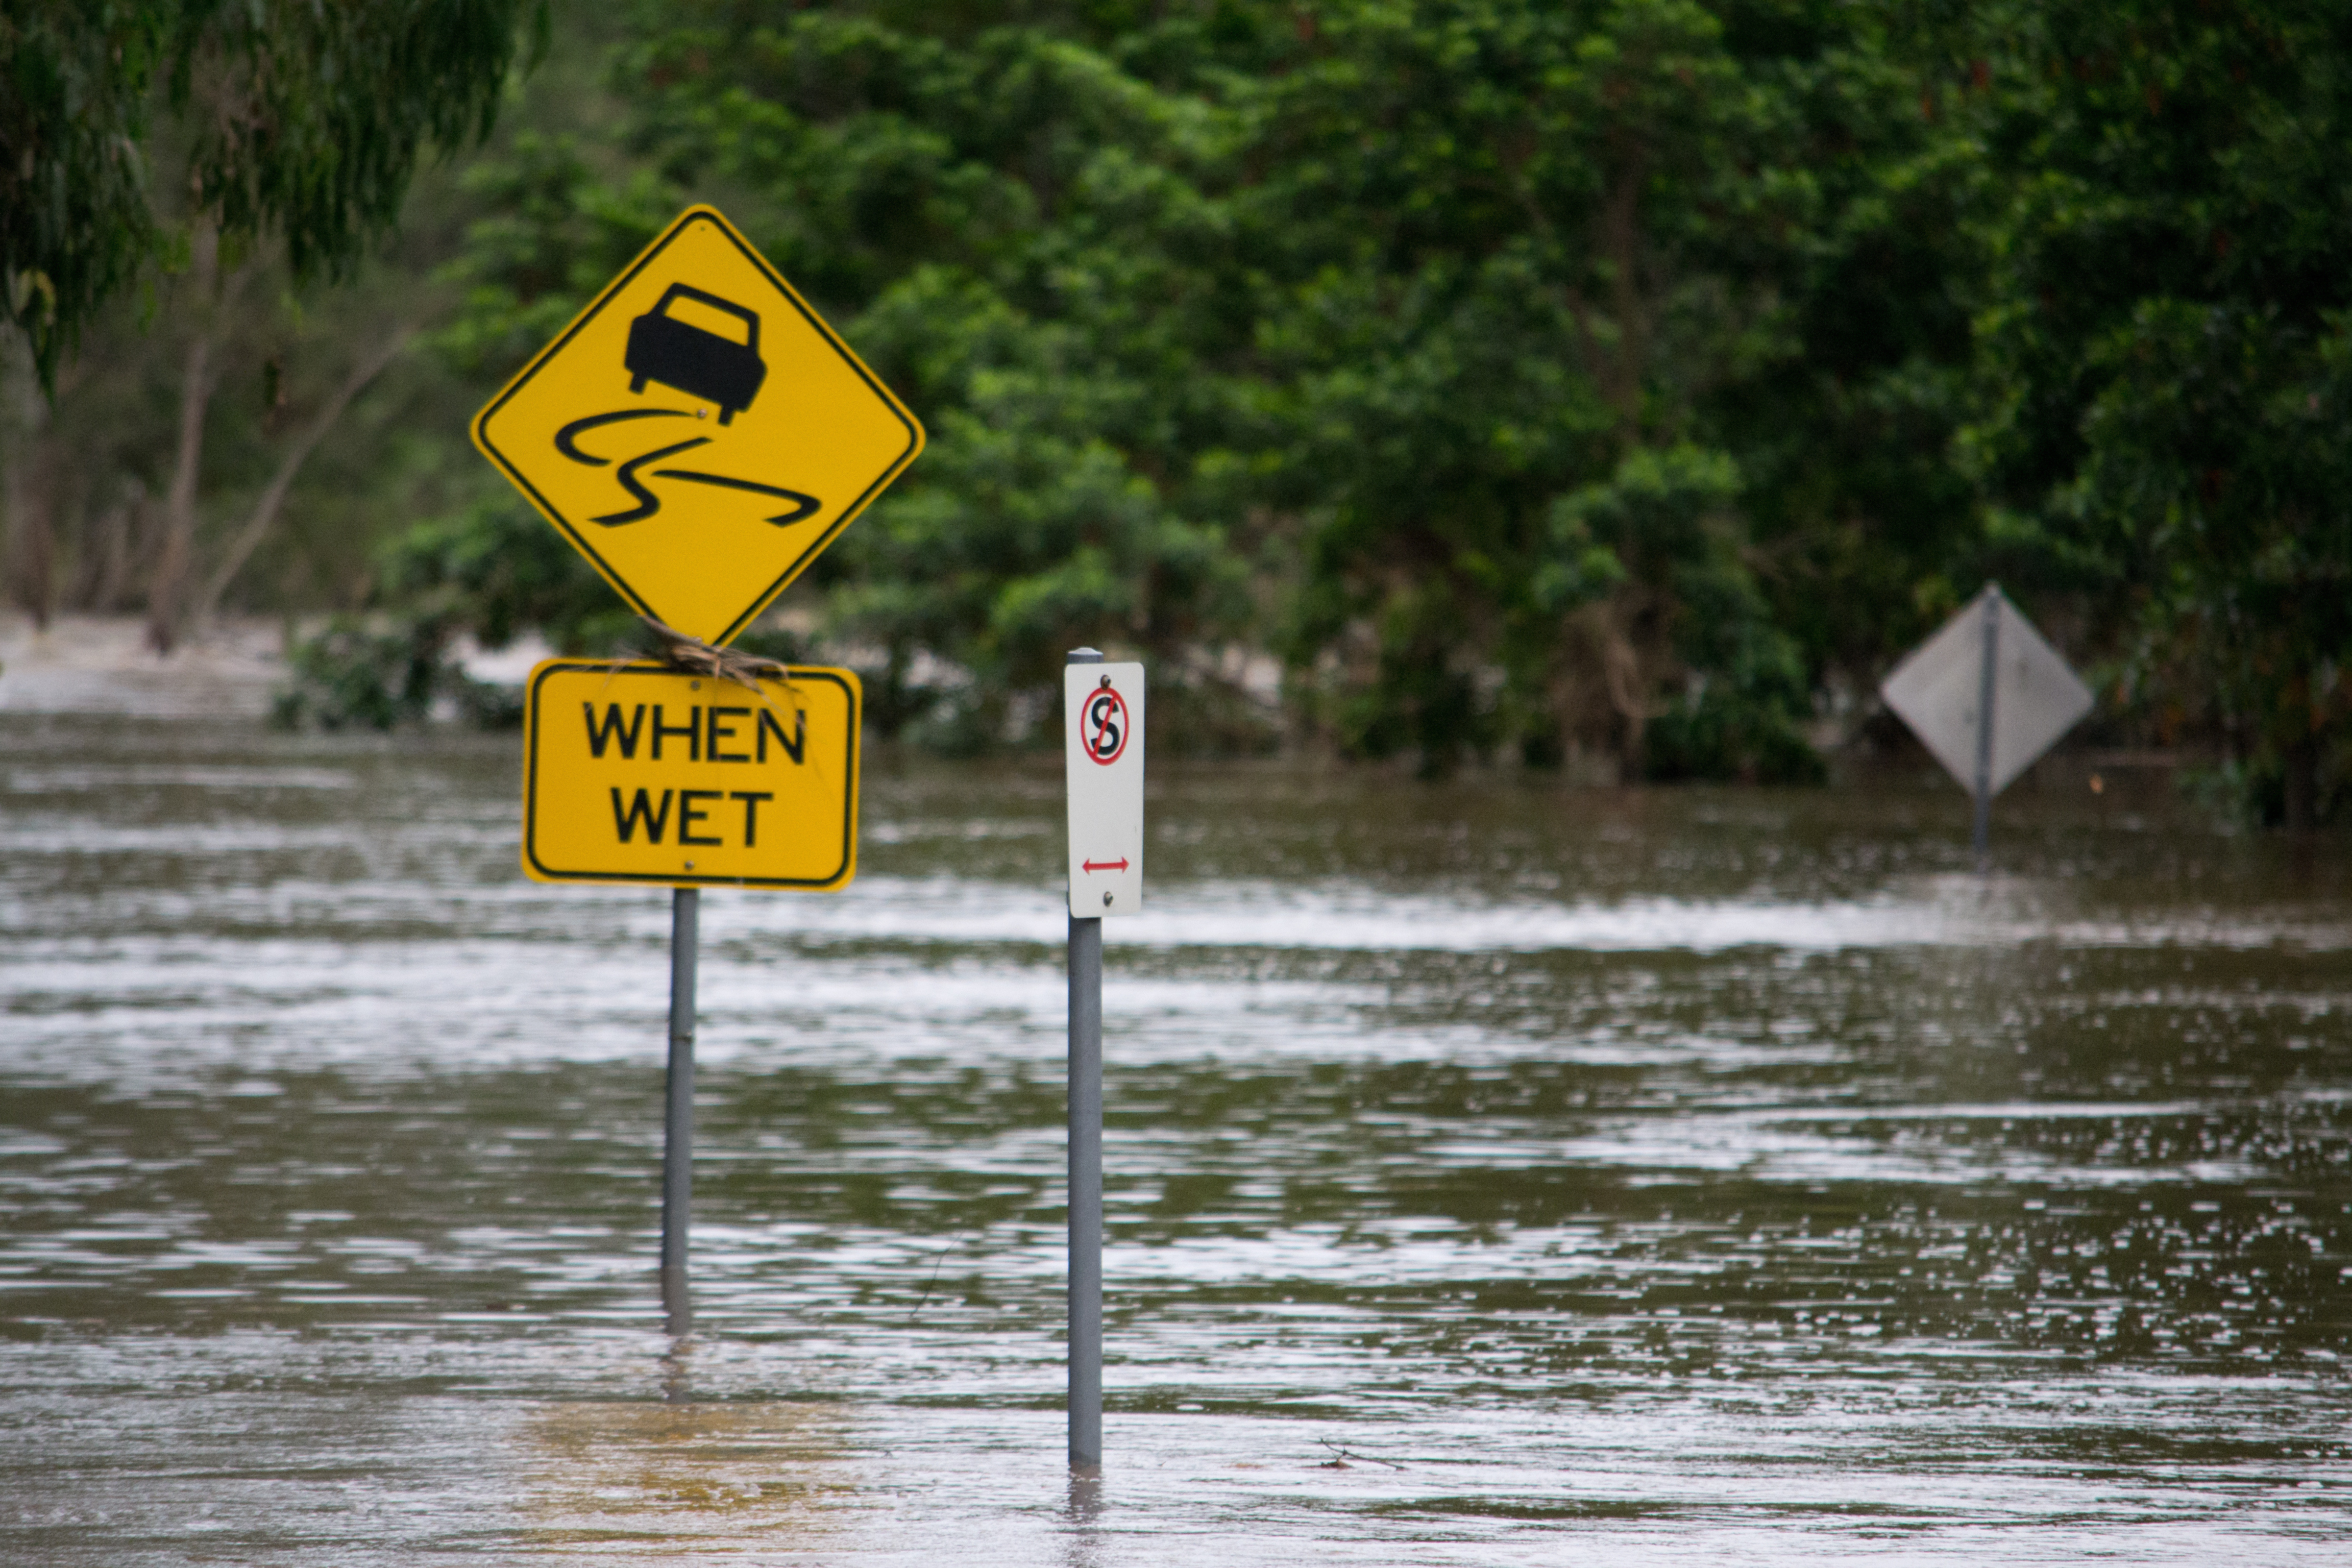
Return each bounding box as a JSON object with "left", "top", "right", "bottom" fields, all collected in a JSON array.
[{"left": 1966, "top": 0, "right": 2352, "bottom": 827}]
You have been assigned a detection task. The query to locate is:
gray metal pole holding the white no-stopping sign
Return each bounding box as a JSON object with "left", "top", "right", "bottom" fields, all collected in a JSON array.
[{"left": 1070, "top": 649, "right": 1103, "bottom": 1469}]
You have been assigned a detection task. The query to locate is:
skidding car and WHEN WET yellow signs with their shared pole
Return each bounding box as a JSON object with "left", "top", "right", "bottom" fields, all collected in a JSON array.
[{"left": 473, "top": 207, "right": 922, "bottom": 1335}]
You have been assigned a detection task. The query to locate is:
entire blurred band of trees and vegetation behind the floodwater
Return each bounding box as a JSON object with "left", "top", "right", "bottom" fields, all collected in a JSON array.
[{"left": 0, "top": 0, "right": 2352, "bottom": 825}]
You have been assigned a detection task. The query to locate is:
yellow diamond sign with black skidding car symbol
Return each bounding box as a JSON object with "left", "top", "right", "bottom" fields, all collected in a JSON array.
[{"left": 473, "top": 207, "right": 922, "bottom": 644}]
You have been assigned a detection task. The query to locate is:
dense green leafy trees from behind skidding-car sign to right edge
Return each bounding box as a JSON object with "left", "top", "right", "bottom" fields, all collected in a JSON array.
[{"left": 14, "top": 0, "right": 2352, "bottom": 820}]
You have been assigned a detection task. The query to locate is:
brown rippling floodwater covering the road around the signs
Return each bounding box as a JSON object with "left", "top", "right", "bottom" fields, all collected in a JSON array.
[{"left": 0, "top": 715, "right": 2352, "bottom": 1568}]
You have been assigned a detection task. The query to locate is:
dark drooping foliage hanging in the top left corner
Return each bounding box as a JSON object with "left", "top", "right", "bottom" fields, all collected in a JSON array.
[{"left": 0, "top": 0, "right": 548, "bottom": 381}]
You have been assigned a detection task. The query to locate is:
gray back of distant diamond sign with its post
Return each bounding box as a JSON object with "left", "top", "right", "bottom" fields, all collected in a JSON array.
[{"left": 1879, "top": 583, "right": 2091, "bottom": 872}]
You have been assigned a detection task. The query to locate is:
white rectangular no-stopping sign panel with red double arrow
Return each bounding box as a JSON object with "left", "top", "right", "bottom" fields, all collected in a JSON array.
[{"left": 1061, "top": 665, "right": 1143, "bottom": 915}]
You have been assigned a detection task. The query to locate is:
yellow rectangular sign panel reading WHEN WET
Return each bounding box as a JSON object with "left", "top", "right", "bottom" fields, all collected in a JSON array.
[{"left": 522, "top": 658, "right": 861, "bottom": 891}]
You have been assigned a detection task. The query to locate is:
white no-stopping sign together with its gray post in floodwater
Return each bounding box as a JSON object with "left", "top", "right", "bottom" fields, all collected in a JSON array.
[{"left": 1063, "top": 649, "right": 1143, "bottom": 1469}]
